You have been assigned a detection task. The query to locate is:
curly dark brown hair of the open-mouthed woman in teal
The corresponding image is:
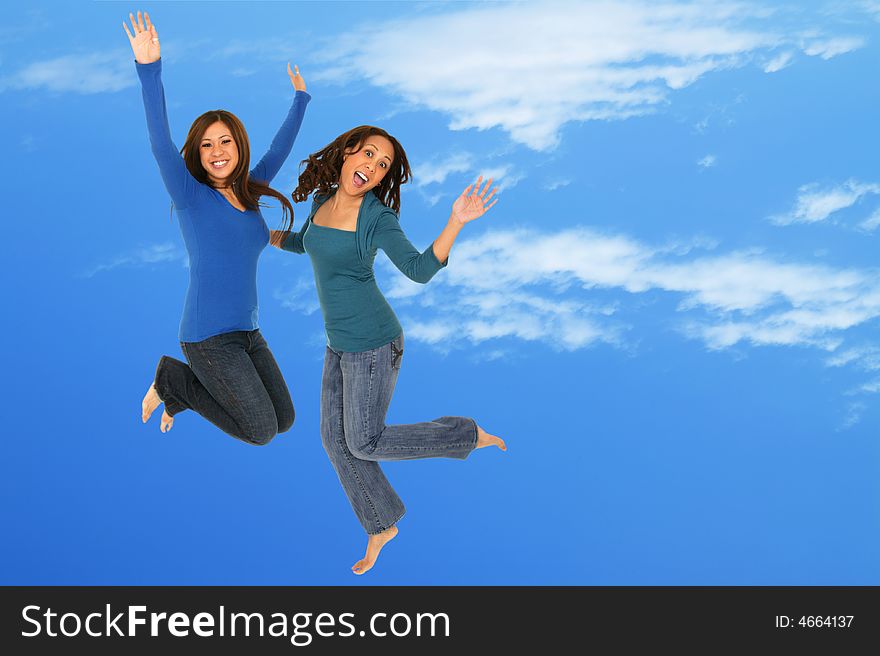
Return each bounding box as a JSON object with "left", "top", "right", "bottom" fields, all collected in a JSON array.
[{"left": 292, "top": 125, "right": 412, "bottom": 212}]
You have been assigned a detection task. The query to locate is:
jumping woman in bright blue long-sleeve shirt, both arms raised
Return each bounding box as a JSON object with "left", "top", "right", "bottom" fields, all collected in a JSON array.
[{"left": 123, "top": 12, "right": 311, "bottom": 445}]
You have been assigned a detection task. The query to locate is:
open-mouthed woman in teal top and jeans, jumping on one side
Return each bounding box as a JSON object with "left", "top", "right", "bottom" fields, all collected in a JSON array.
[{"left": 272, "top": 126, "right": 506, "bottom": 574}]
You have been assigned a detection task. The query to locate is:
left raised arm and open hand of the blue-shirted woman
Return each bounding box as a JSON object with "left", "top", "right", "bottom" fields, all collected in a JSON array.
[{"left": 122, "top": 12, "right": 198, "bottom": 209}]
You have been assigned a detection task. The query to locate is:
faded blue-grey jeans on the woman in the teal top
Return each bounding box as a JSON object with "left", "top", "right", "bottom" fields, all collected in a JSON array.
[{"left": 321, "top": 335, "right": 477, "bottom": 535}]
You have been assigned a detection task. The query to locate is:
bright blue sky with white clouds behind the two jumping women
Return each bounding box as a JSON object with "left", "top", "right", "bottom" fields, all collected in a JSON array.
[{"left": 0, "top": 1, "right": 880, "bottom": 585}]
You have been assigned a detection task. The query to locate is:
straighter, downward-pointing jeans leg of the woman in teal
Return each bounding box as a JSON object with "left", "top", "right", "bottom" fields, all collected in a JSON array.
[{"left": 321, "top": 348, "right": 406, "bottom": 535}]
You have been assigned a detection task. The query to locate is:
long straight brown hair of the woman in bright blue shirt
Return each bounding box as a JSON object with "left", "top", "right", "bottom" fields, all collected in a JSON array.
[{"left": 180, "top": 109, "right": 293, "bottom": 232}]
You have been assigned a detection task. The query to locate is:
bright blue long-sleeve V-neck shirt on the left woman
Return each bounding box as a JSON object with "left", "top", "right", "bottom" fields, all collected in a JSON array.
[{"left": 137, "top": 60, "right": 311, "bottom": 342}]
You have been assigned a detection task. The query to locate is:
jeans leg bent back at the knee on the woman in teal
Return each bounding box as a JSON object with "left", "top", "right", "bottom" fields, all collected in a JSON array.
[{"left": 341, "top": 335, "right": 478, "bottom": 461}]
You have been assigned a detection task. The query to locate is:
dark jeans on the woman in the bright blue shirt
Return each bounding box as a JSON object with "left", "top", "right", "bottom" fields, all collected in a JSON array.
[{"left": 156, "top": 330, "right": 295, "bottom": 445}]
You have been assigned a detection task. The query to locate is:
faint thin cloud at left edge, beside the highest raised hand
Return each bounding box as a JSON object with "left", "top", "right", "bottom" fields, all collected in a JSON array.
[{"left": 0, "top": 52, "right": 137, "bottom": 94}]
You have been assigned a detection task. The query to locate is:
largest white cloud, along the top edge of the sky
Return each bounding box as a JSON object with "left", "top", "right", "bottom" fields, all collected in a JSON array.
[{"left": 315, "top": 0, "right": 862, "bottom": 150}]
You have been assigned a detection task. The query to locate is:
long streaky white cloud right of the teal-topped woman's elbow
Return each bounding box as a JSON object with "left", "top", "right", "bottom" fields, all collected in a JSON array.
[{"left": 368, "top": 222, "right": 880, "bottom": 357}]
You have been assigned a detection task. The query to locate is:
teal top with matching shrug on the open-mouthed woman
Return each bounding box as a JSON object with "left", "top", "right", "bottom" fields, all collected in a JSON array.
[{"left": 281, "top": 192, "right": 446, "bottom": 353}]
